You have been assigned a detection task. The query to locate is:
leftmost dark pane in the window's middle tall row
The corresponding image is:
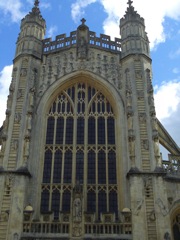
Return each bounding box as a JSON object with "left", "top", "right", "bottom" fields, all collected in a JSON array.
[{"left": 43, "top": 150, "right": 52, "bottom": 183}]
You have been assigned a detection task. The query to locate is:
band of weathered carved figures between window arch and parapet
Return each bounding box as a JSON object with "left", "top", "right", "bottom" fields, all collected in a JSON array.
[{"left": 35, "top": 47, "right": 122, "bottom": 97}]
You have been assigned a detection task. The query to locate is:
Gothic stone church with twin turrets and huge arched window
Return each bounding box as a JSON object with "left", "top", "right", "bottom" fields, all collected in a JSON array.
[{"left": 0, "top": 0, "right": 180, "bottom": 240}]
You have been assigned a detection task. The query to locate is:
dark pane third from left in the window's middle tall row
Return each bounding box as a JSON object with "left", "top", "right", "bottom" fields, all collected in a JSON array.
[{"left": 64, "top": 151, "right": 72, "bottom": 183}]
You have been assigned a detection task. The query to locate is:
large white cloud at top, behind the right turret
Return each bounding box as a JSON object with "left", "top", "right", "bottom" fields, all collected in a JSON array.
[{"left": 71, "top": 0, "right": 180, "bottom": 48}]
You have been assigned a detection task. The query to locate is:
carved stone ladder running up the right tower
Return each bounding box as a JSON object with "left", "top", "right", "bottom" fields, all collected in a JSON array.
[{"left": 135, "top": 61, "right": 157, "bottom": 240}]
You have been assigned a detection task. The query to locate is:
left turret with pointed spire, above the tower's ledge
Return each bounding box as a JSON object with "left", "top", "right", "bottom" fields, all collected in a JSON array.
[{"left": 15, "top": 0, "right": 46, "bottom": 58}]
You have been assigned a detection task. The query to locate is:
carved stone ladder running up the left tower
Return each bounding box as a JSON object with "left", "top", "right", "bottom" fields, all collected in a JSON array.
[{"left": 0, "top": 60, "right": 28, "bottom": 240}]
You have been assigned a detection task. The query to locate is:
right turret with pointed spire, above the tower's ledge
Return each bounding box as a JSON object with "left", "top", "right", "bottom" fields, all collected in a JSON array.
[{"left": 120, "top": 0, "right": 150, "bottom": 57}]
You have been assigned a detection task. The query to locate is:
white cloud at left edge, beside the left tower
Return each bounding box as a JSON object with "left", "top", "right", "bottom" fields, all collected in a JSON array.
[{"left": 0, "top": 65, "right": 13, "bottom": 127}]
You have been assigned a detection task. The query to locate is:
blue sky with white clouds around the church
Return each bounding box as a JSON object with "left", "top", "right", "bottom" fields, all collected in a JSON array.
[{"left": 0, "top": 0, "right": 180, "bottom": 157}]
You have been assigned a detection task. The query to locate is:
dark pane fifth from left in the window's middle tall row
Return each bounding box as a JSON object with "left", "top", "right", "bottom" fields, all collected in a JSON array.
[{"left": 87, "top": 151, "right": 96, "bottom": 184}]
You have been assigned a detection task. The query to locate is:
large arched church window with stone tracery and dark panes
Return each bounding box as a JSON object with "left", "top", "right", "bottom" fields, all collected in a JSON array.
[{"left": 41, "top": 83, "right": 118, "bottom": 219}]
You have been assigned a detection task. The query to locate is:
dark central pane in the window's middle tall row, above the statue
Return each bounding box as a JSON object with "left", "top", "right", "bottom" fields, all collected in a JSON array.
[{"left": 76, "top": 151, "right": 84, "bottom": 183}]
